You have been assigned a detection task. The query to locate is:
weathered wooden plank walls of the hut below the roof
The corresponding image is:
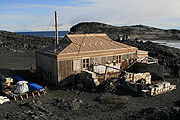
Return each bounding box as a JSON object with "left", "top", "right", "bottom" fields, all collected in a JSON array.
[{"left": 36, "top": 51, "right": 133, "bottom": 85}]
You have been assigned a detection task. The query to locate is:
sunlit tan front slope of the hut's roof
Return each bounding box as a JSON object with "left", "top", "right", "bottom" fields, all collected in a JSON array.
[{"left": 59, "top": 34, "right": 134, "bottom": 57}]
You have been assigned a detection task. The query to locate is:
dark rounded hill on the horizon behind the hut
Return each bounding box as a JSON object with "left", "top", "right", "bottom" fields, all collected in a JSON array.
[{"left": 70, "top": 22, "right": 180, "bottom": 40}]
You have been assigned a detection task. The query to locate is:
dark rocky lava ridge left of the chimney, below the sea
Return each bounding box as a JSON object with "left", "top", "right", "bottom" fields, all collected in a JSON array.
[{"left": 0, "top": 31, "right": 54, "bottom": 54}]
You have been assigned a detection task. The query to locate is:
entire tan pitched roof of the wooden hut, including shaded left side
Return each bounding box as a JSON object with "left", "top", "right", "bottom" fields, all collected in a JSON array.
[{"left": 37, "top": 34, "right": 137, "bottom": 58}]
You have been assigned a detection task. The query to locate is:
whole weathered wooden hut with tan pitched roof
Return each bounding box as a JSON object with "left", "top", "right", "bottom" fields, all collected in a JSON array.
[{"left": 36, "top": 34, "right": 138, "bottom": 85}]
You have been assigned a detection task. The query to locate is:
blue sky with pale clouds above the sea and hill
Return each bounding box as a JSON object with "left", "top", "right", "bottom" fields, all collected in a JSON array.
[{"left": 0, "top": 0, "right": 180, "bottom": 32}]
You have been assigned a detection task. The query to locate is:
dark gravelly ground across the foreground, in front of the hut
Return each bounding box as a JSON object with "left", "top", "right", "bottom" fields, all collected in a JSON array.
[{"left": 0, "top": 75, "right": 180, "bottom": 120}]
